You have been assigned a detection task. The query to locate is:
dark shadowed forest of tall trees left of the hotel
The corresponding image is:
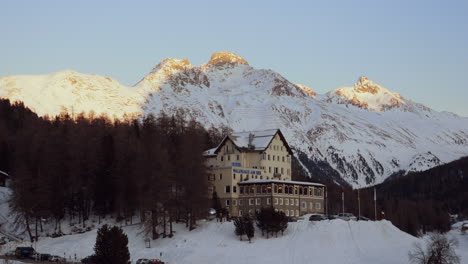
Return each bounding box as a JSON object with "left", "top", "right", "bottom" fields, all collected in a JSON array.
[{"left": 0, "top": 100, "right": 227, "bottom": 240}]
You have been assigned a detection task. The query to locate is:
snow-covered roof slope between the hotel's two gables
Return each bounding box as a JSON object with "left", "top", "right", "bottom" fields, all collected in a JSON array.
[{"left": 229, "top": 129, "right": 278, "bottom": 150}]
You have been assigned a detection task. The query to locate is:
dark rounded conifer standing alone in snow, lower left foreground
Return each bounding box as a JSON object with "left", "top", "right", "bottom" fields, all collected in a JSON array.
[{"left": 94, "top": 225, "right": 130, "bottom": 264}]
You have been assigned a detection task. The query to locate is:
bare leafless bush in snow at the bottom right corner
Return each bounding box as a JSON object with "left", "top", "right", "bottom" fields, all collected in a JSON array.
[{"left": 408, "top": 233, "right": 460, "bottom": 264}]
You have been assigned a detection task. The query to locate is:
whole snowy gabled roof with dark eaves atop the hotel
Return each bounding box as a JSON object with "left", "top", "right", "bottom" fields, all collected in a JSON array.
[{"left": 204, "top": 129, "right": 293, "bottom": 156}]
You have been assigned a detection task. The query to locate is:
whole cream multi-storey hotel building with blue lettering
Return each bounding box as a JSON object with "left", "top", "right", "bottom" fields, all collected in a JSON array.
[{"left": 205, "top": 129, "right": 325, "bottom": 216}]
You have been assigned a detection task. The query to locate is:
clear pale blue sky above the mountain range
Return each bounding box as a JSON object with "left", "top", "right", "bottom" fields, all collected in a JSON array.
[{"left": 0, "top": 0, "right": 468, "bottom": 117}]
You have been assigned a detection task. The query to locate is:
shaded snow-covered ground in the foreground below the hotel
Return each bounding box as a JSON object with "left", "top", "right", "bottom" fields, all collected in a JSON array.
[{"left": 0, "top": 220, "right": 468, "bottom": 264}]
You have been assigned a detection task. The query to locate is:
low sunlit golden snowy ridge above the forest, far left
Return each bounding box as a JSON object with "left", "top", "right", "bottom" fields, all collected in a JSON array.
[{"left": 0, "top": 70, "right": 141, "bottom": 118}]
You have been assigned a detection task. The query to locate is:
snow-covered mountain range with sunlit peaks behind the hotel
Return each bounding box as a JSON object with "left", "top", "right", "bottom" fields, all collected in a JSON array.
[{"left": 0, "top": 52, "right": 468, "bottom": 186}]
